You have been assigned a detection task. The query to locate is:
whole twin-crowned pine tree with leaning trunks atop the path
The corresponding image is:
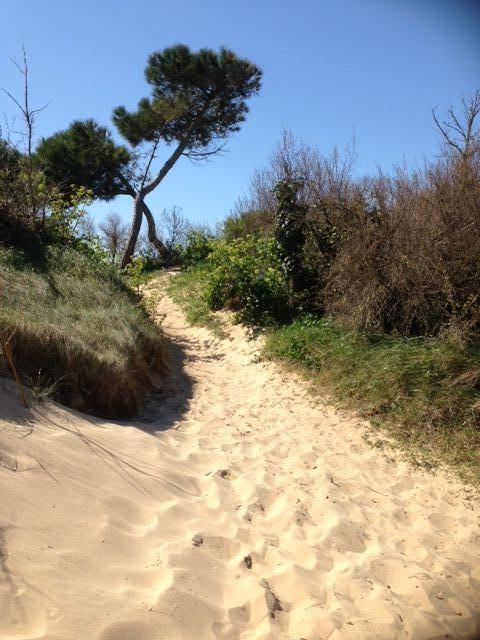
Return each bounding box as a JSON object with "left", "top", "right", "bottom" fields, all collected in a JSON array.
[{"left": 38, "top": 45, "right": 262, "bottom": 266}]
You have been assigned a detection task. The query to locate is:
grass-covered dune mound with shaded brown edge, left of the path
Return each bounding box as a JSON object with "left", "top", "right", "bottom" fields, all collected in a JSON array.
[{"left": 0, "top": 249, "right": 163, "bottom": 418}]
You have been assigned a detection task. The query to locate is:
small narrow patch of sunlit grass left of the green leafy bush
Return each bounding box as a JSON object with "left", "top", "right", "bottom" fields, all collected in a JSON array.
[{"left": 167, "top": 263, "right": 225, "bottom": 337}]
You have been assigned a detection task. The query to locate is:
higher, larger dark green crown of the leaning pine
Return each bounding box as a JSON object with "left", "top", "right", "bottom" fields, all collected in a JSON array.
[{"left": 113, "top": 45, "right": 261, "bottom": 149}]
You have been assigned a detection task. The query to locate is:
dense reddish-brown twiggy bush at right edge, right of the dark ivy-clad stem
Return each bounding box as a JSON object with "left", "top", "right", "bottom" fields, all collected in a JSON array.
[{"left": 328, "top": 155, "right": 480, "bottom": 335}]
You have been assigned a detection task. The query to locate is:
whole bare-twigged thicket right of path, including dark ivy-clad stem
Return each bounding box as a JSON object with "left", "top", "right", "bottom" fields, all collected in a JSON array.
[{"left": 224, "top": 99, "right": 480, "bottom": 339}]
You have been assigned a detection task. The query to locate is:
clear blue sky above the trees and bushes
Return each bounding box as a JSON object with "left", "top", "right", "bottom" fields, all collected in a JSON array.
[{"left": 0, "top": 0, "right": 480, "bottom": 229}]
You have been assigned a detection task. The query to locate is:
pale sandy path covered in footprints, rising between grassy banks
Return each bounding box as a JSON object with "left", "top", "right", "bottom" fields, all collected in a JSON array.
[{"left": 0, "top": 286, "right": 480, "bottom": 640}]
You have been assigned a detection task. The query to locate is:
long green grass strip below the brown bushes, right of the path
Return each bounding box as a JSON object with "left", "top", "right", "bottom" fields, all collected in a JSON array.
[{"left": 266, "top": 318, "right": 480, "bottom": 484}]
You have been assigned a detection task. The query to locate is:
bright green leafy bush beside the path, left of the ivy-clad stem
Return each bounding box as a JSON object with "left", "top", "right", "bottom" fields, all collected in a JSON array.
[{"left": 208, "top": 236, "right": 290, "bottom": 326}]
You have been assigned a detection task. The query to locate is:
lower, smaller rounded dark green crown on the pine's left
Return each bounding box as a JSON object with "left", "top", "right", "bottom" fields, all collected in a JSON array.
[{"left": 37, "top": 120, "right": 132, "bottom": 200}]
